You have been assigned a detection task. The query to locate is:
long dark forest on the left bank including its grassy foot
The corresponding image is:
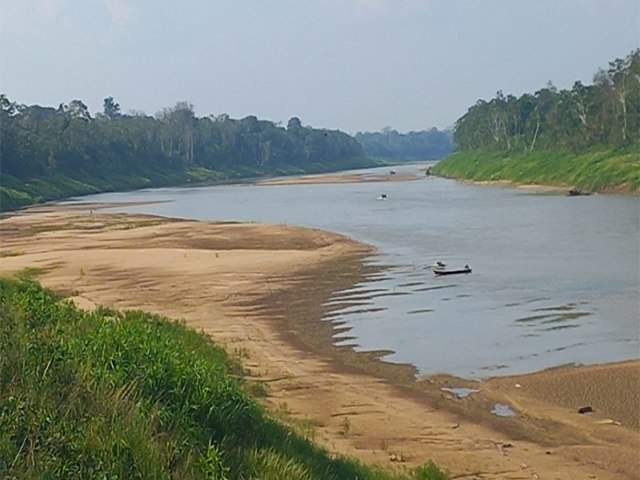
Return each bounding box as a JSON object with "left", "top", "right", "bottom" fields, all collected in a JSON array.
[{"left": 0, "top": 95, "right": 373, "bottom": 210}]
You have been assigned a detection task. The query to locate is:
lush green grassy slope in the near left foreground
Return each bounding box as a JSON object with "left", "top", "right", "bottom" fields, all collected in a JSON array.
[{"left": 0, "top": 278, "right": 446, "bottom": 480}]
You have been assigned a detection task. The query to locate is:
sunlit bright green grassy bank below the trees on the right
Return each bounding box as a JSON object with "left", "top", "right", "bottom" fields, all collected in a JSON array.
[{"left": 432, "top": 148, "right": 640, "bottom": 193}]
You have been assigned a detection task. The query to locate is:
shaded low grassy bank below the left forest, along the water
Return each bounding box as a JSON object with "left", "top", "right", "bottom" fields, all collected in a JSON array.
[{"left": 0, "top": 157, "right": 388, "bottom": 211}]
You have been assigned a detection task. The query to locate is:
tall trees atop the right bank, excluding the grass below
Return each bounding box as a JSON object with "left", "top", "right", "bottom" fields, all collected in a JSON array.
[{"left": 454, "top": 49, "right": 640, "bottom": 153}]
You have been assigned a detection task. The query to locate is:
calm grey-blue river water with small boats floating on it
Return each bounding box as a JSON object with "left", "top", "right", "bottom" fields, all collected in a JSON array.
[{"left": 72, "top": 165, "right": 640, "bottom": 378}]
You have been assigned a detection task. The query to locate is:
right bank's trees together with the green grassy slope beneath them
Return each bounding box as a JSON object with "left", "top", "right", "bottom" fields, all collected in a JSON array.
[{"left": 432, "top": 50, "right": 640, "bottom": 193}]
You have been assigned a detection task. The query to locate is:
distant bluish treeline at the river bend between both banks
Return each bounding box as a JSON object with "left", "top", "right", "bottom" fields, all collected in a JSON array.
[{"left": 355, "top": 127, "right": 453, "bottom": 161}]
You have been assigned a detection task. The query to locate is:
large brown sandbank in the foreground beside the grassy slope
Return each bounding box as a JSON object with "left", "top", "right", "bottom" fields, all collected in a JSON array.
[{"left": 0, "top": 206, "right": 640, "bottom": 479}]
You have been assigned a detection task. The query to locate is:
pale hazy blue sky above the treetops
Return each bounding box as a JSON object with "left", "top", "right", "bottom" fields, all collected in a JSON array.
[{"left": 0, "top": 0, "right": 640, "bottom": 134}]
